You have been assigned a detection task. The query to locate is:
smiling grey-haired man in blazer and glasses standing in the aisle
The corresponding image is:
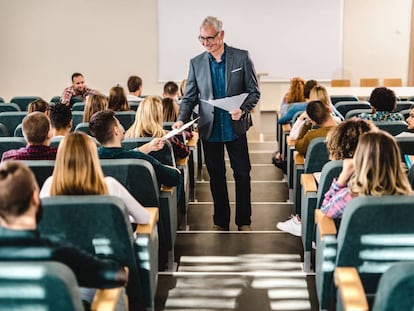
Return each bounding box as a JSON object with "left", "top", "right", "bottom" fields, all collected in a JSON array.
[{"left": 173, "top": 16, "right": 260, "bottom": 231}]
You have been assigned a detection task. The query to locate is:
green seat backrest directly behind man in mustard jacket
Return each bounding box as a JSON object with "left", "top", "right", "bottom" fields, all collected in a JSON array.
[{"left": 304, "top": 137, "right": 329, "bottom": 173}]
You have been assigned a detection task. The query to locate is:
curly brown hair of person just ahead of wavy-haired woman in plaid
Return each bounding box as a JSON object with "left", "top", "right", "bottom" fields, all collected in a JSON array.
[{"left": 326, "top": 118, "right": 377, "bottom": 160}]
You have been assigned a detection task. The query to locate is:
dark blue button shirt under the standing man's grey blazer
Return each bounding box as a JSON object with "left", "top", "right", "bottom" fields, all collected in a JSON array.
[{"left": 207, "top": 50, "right": 237, "bottom": 142}]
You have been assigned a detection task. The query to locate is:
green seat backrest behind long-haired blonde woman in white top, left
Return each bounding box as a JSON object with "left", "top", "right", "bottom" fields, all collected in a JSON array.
[{"left": 39, "top": 195, "right": 142, "bottom": 299}]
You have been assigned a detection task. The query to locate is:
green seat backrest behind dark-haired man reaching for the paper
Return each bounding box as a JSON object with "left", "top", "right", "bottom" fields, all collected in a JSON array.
[{"left": 100, "top": 159, "right": 160, "bottom": 207}]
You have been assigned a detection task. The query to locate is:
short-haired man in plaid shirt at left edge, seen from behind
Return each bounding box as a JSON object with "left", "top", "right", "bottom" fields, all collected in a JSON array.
[{"left": 1, "top": 111, "right": 57, "bottom": 161}]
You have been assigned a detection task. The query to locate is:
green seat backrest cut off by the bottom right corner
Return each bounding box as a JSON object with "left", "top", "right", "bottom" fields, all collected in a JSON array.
[{"left": 372, "top": 262, "right": 414, "bottom": 311}]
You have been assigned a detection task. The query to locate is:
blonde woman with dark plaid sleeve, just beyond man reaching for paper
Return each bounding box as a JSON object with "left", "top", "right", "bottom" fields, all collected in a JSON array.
[{"left": 125, "top": 96, "right": 190, "bottom": 158}]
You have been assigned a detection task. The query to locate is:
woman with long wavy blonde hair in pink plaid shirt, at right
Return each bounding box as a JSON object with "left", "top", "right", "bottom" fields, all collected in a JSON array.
[{"left": 321, "top": 131, "right": 412, "bottom": 218}]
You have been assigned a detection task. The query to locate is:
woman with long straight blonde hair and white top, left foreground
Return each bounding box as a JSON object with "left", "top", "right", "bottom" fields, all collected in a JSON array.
[{"left": 40, "top": 132, "right": 149, "bottom": 224}]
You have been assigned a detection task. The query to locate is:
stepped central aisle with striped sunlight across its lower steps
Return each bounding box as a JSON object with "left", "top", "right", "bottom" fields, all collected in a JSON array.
[{"left": 156, "top": 142, "right": 317, "bottom": 311}]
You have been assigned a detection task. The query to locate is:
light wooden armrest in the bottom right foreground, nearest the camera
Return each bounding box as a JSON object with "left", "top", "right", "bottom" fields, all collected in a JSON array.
[{"left": 335, "top": 267, "right": 368, "bottom": 311}]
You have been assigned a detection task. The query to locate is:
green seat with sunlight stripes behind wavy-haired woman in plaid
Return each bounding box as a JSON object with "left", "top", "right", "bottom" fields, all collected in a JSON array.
[{"left": 316, "top": 195, "right": 414, "bottom": 310}]
